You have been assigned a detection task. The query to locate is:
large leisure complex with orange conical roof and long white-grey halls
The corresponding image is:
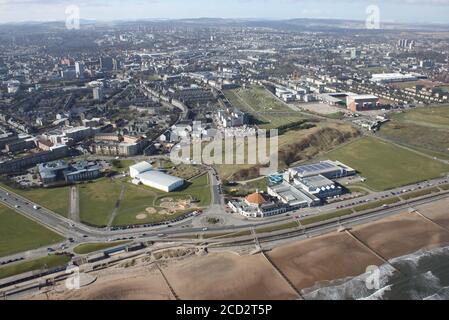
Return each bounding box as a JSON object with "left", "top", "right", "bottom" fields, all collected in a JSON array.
[{"left": 228, "top": 160, "right": 356, "bottom": 218}]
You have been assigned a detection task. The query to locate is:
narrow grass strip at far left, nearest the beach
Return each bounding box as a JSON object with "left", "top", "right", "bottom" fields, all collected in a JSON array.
[{"left": 0, "top": 255, "right": 72, "bottom": 279}]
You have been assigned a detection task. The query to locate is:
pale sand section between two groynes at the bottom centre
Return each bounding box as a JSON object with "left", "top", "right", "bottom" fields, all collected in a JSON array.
[{"left": 164, "top": 253, "right": 297, "bottom": 300}]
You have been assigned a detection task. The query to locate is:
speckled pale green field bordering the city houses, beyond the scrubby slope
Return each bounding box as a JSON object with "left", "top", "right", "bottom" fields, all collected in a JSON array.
[{"left": 224, "top": 86, "right": 305, "bottom": 129}]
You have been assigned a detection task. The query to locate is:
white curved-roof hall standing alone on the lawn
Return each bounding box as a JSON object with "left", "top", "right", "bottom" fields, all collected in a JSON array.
[{"left": 129, "top": 161, "right": 185, "bottom": 192}]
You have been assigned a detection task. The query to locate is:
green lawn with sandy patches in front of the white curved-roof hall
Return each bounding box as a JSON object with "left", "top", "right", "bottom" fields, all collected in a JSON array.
[{"left": 113, "top": 174, "right": 212, "bottom": 226}]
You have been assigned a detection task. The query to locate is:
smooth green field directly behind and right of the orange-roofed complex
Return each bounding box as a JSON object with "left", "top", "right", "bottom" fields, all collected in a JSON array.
[{"left": 324, "top": 138, "right": 449, "bottom": 190}]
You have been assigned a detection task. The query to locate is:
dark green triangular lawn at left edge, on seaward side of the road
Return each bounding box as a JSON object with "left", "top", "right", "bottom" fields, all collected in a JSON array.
[{"left": 0, "top": 206, "right": 64, "bottom": 257}]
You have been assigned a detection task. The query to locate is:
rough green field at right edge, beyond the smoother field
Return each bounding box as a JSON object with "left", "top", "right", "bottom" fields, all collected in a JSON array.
[{"left": 379, "top": 106, "right": 449, "bottom": 159}]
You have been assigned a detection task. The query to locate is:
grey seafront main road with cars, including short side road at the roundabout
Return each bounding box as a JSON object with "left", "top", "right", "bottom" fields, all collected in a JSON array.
[{"left": 0, "top": 172, "right": 449, "bottom": 242}]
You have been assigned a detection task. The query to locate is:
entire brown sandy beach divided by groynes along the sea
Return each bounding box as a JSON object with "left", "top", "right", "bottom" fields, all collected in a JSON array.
[{"left": 26, "top": 200, "right": 449, "bottom": 300}]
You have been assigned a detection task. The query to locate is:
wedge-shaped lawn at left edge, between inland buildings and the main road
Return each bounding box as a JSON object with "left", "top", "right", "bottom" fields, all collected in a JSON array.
[{"left": 2, "top": 185, "right": 70, "bottom": 217}]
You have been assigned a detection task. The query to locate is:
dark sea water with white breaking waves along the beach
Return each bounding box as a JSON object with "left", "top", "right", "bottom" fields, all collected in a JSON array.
[{"left": 303, "top": 247, "right": 449, "bottom": 300}]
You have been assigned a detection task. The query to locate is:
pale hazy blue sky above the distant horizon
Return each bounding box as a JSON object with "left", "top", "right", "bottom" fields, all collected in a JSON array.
[{"left": 0, "top": 0, "right": 449, "bottom": 24}]
